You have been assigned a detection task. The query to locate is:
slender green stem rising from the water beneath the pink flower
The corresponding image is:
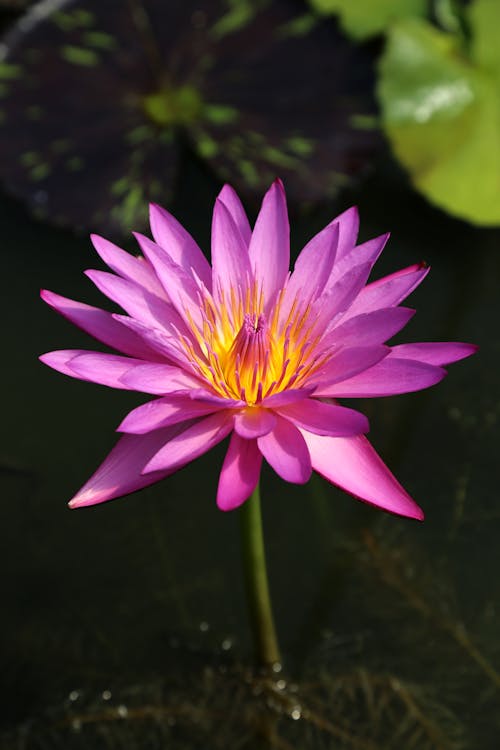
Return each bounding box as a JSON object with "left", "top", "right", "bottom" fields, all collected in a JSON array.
[{"left": 240, "top": 485, "right": 281, "bottom": 667}]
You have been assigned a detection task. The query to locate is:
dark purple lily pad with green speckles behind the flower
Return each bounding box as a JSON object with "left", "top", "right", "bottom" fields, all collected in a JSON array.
[{"left": 0, "top": 0, "right": 378, "bottom": 234}]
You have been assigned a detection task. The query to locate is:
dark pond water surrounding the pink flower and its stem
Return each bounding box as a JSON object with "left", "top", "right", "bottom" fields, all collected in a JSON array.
[{"left": 0, "top": 159, "right": 500, "bottom": 750}]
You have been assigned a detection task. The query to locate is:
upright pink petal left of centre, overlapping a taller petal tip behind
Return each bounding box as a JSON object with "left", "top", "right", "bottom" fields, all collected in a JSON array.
[{"left": 212, "top": 200, "right": 252, "bottom": 300}]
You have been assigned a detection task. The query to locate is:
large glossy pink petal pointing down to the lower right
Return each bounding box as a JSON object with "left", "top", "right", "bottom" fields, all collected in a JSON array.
[{"left": 302, "top": 430, "right": 424, "bottom": 521}]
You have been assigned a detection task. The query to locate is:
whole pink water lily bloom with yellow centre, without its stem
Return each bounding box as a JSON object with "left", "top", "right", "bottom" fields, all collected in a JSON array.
[{"left": 41, "top": 180, "right": 475, "bottom": 519}]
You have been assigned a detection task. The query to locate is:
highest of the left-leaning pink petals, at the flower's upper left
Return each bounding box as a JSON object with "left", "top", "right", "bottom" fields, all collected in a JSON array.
[{"left": 149, "top": 203, "right": 212, "bottom": 289}]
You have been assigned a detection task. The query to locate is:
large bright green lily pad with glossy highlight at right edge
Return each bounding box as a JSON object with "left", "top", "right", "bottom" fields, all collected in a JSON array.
[{"left": 378, "top": 13, "right": 500, "bottom": 225}]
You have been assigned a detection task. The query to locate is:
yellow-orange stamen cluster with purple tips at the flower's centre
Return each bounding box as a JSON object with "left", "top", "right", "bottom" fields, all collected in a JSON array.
[{"left": 183, "top": 288, "right": 325, "bottom": 406}]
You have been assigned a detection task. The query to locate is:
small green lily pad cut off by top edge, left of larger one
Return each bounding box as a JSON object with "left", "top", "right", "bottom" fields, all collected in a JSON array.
[{"left": 310, "top": 0, "right": 428, "bottom": 39}]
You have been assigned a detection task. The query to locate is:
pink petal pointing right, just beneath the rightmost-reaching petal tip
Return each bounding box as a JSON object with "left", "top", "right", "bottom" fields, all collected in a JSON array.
[{"left": 314, "top": 355, "right": 446, "bottom": 398}]
